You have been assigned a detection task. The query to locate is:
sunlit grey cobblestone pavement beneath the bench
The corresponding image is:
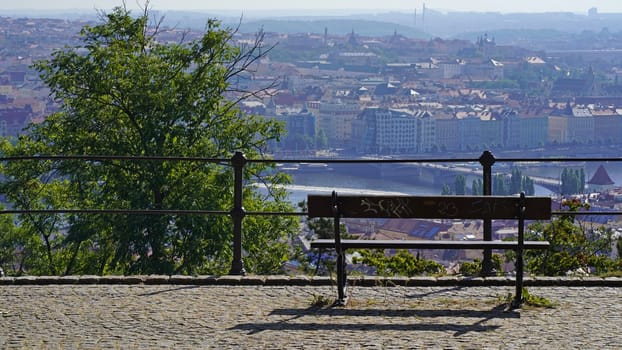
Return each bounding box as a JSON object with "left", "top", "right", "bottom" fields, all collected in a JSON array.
[{"left": 0, "top": 284, "right": 622, "bottom": 350}]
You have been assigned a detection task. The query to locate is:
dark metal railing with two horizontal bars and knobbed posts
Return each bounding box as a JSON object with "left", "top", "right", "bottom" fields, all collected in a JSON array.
[{"left": 0, "top": 151, "right": 622, "bottom": 275}]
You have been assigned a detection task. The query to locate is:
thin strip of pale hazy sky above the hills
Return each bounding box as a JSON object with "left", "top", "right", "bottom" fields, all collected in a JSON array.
[{"left": 0, "top": 0, "right": 622, "bottom": 16}]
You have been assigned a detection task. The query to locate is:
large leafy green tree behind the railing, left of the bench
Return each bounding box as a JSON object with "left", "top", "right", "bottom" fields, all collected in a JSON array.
[{"left": 2, "top": 3, "right": 297, "bottom": 274}]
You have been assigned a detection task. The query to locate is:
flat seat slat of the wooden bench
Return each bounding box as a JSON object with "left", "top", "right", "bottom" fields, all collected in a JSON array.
[{"left": 311, "top": 239, "right": 550, "bottom": 249}]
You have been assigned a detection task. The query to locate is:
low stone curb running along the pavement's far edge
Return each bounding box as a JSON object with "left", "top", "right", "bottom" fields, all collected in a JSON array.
[{"left": 0, "top": 275, "right": 622, "bottom": 287}]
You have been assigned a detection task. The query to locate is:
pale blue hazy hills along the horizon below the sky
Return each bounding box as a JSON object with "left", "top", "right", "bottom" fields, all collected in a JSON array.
[{"left": 6, "top": 9, "right": 622, "bottom": 48}]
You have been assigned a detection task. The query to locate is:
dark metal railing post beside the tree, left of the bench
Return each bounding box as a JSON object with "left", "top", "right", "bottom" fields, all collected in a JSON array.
[{"left": 229, "top": 152, "right": 246, "bottom": 275}]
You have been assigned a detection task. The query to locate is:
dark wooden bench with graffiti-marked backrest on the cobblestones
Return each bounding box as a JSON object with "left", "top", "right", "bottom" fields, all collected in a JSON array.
[{"left": 307, "top": 192, "right": 551, "bottom": 307}]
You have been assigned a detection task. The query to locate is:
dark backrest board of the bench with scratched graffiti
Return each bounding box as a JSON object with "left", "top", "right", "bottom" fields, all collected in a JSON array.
[{"left": 307, "top": 193, "right": 551, "bottom": 220}]
